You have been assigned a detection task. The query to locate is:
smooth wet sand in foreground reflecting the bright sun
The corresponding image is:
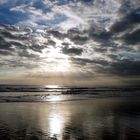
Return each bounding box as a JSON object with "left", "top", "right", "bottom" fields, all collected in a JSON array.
[{"left": 0, "top": 95, "right": 140, "bottom": 140}]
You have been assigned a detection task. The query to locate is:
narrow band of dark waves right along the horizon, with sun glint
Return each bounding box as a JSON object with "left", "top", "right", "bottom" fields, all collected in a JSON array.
[{"left": 0, "top": 85, "right": 140, "bottom": 94}]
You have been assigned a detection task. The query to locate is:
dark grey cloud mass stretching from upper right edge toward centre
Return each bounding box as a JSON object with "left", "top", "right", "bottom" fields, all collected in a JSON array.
[{"left": 87, "top": 5, "right": 140, "bottom": 47}]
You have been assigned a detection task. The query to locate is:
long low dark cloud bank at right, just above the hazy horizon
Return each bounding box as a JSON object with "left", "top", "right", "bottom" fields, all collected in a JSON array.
[{"left": 71, "top": 55, "right": 140, "bottom": 76}]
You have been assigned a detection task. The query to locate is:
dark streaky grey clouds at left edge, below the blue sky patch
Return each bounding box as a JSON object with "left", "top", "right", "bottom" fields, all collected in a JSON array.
[{"left": 0, "top": 25, "right": 46, "bottom": 56}]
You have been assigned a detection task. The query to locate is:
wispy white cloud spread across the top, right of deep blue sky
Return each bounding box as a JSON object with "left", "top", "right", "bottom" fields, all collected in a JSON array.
[{"left": 6, "top": 0, "right": 120, "bottom": 31}]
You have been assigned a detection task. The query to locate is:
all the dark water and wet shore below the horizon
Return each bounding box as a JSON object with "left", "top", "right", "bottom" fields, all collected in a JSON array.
[{"left": 0, "top": 85, "right": 140, "bottom": 140}]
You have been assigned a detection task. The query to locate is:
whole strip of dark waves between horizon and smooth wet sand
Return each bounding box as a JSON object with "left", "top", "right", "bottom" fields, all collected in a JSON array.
[{"left": 0, "top": 85, "right": 140, "bottom": 102}]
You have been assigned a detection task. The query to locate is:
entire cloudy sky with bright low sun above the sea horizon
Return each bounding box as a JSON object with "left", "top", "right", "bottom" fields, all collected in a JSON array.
[{"left": 0, "top": 0, "right": 140, "bottom": 86}]
